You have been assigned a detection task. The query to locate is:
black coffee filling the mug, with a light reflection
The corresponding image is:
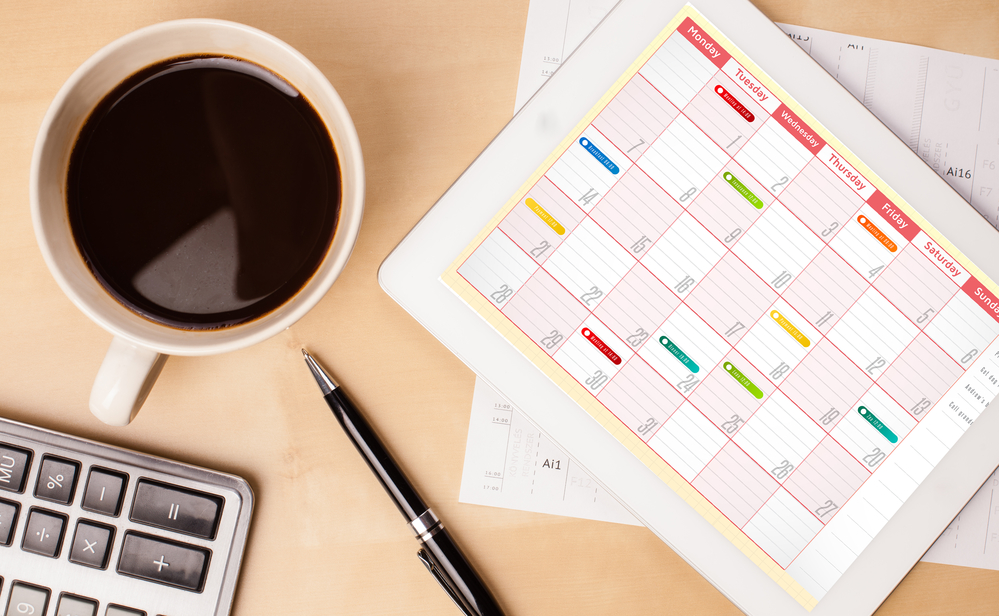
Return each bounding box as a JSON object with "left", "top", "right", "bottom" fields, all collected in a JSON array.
[{"left": 67, "top": 56, "right": 340, "bottom": 329}]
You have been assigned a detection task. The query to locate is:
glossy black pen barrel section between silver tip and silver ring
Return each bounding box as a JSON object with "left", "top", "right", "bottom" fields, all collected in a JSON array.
[{"left": 325, "top": 387, "right": 427, "bottom": 522}]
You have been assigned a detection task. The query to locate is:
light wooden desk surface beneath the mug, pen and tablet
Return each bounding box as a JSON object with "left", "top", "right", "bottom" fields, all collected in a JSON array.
[{"left": 0, "top": 0, "right": 999, "bottom": 616}]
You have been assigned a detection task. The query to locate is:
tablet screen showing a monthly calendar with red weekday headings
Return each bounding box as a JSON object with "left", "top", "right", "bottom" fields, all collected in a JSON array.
[{"left": 441, "top": 5, "right": 999, "bottom": 609}]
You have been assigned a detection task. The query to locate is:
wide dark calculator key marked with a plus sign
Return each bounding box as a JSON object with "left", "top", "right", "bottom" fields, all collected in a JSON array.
[{"left": 118, "top": 533, "right": 209, "bottom": 592}]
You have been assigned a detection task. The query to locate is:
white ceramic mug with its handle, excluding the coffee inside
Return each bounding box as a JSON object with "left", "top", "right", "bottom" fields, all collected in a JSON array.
[{"left": 31, "top": 19, "right": 364, "bottom": 426}]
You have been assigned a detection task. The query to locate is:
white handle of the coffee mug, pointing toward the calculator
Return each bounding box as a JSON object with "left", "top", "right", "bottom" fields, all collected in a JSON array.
[{"left": 90, "top": 336, "right": 170, "bottom": 426}]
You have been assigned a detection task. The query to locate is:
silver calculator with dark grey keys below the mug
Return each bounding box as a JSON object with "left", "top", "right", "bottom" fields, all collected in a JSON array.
[{"left": 0, "top": 418, "right": 253, "bottom": 616}]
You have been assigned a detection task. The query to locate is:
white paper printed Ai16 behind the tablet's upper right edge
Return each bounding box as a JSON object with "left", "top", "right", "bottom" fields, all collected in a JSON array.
[{"left": 777, "top": 24, "right": 999, "bottom": 227}]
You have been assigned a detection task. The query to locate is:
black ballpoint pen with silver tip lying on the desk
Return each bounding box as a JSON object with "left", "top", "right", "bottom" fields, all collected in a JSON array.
[{"left": 302, "top": 349, "right": 503, "bottom": 616}]
